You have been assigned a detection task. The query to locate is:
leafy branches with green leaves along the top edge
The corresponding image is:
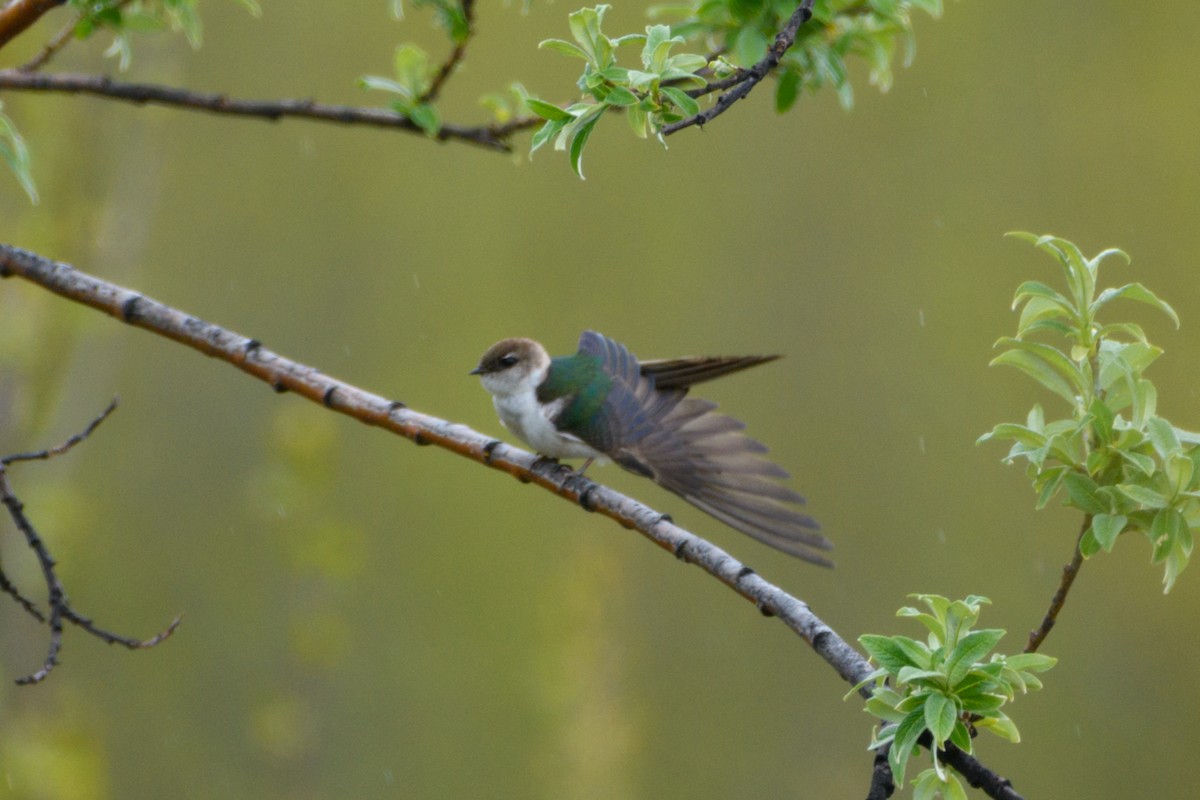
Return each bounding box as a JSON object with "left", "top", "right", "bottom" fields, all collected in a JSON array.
[{"left": 0, "top": 0, "right": 942, "bottom": 196}]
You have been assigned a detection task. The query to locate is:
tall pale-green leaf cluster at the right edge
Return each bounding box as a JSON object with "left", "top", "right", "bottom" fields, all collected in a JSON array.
[{"left": 979, "top": 233, "right": 1200, "bottom": 590}]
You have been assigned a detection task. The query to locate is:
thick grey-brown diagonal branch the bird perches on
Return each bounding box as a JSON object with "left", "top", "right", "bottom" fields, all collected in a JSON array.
[{"left": 0, "top": 245, "right": 1020, "bottom": 800}]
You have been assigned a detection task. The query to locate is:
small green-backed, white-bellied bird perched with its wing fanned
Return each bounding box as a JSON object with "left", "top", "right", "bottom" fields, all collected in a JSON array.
[{"left": 469, "top": 331, "right": 833, "bottom": 566}]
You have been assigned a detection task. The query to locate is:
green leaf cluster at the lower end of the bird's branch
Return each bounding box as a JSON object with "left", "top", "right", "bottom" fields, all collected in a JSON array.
[{"left": 854, "top": 595, "right": 1056, "bottom": 800}]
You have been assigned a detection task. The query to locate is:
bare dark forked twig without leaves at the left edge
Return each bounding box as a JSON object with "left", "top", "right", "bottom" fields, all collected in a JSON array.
[{"left": 0, "top": 398, "right": 181, "bottom": 685}]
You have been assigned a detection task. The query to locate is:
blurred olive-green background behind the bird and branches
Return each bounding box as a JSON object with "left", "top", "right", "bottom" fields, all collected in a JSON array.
[{"left": 0, "top": 0, "right": 1200, "bottom": 800}]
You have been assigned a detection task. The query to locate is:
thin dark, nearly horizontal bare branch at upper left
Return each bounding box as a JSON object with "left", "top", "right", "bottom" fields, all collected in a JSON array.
[{"left": 0, "top": 70, "right": 540, "bottom": 152}]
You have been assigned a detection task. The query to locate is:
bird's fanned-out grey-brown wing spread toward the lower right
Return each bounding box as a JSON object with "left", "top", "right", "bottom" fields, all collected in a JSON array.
[{"left": 580, "top": 331, "right": 832, "bottom": 566}]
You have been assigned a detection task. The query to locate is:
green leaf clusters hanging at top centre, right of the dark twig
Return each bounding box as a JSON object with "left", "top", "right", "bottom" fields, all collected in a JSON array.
[{"left": 528, "top": 0, "right": 942, "bottom": 178}]
